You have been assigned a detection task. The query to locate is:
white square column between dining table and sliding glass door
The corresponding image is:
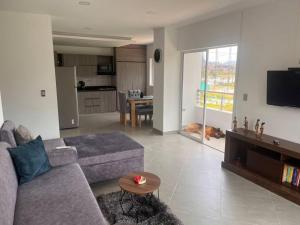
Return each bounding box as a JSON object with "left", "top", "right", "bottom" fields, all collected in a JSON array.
[{"left": 153, "top": 28, "right": 181, "bottom": 132}]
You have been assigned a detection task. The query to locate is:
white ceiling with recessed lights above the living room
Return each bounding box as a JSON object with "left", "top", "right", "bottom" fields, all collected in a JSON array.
[{"left": 0, "top": 0, "right": 267, "bottom": 46}]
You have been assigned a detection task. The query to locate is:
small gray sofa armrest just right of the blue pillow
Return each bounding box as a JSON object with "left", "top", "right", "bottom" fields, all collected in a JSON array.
[{"left": 46, "top": 146, "right": 77, "bottom": 167}]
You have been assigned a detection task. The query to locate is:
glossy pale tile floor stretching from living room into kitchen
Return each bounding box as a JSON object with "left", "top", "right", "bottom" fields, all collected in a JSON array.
[{"left": 62, "top": 113, "right": 300, "bottom": 225}]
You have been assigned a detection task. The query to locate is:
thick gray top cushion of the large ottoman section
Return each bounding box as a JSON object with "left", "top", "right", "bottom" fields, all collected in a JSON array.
[{"left": 64, "top": 132, "right": 144, "bottom": 166}]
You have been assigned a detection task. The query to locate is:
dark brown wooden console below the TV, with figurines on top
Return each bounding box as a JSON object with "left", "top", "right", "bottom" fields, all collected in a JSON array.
[{"left": 222, "top": 128, "right": 300, "bottom": 205}]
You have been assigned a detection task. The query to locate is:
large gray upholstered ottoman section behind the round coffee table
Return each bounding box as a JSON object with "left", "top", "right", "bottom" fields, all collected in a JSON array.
[{"left": 64, "top": 132, "right": 144, "bottom": 183}]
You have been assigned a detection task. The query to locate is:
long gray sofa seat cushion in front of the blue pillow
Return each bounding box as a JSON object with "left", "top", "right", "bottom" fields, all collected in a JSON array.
[{"left": 14, "top": 163, "right": 107, "bottom": 225}]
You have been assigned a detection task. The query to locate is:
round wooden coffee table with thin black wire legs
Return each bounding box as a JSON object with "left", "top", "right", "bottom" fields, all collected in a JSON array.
[{"left": 119, "top": 172, "right": 160, "bottom": 222}]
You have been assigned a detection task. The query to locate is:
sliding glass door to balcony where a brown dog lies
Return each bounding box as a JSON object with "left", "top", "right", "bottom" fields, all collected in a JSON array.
[{"left": 181, "top": 46, "right": 237, "bottom": 151}]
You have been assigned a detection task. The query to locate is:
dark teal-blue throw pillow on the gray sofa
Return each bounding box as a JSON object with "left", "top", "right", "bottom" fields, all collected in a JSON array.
[{"left": 9, "top": 136, "right": 51, "bottom": 184}]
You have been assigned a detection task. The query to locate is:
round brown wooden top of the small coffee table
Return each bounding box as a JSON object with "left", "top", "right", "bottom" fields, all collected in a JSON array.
[{"left": 119, "top": 172, "right": 160, "bottom": 195}]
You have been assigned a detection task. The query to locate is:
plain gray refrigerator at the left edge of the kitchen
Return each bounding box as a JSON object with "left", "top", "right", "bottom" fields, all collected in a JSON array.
[{"left": 55, "top": 66, "right": 79, "bottom": 129}]
